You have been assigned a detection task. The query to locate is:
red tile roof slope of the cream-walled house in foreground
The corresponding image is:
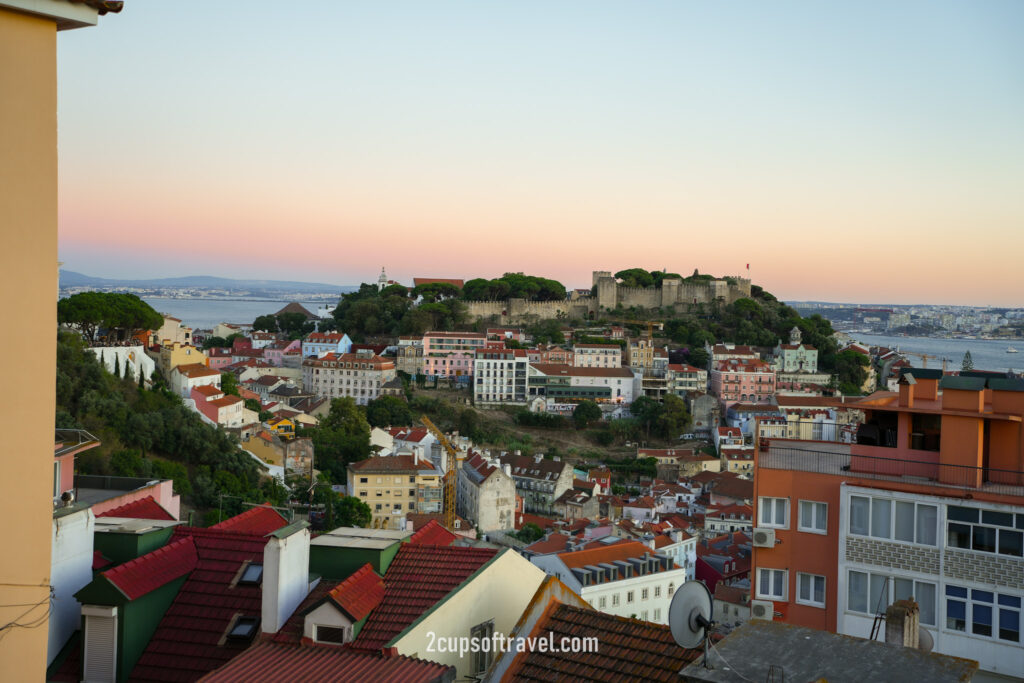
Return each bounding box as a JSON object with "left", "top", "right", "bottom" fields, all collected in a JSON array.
[{"left": 354, "top": 543, "right": 498, "bottom": 651}]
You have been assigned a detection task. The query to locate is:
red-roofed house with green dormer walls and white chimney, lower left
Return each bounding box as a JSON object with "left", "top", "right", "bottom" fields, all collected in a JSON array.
[{"left": 69, "top": 507, "right": 292, "bottom": 681}]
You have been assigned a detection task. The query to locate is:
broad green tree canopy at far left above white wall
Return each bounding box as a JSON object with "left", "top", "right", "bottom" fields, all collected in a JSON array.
[{"left": 57, "top": 292, "right": 164, "bottom": 341}]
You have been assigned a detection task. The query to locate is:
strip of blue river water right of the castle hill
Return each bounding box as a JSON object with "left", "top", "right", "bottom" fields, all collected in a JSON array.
[{"left": 850, "top": 332, "right": 1024, "bottom": 372}]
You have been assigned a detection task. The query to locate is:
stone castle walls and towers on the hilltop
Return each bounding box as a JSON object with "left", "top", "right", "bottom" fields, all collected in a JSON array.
[{"left": 466, "top": 270, "right": 751, "bottom": 324}]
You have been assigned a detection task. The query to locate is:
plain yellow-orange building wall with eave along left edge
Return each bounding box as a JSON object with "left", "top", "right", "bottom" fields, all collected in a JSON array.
[{"left": 0, "top": 0, "right": 121, "bottom": 681}]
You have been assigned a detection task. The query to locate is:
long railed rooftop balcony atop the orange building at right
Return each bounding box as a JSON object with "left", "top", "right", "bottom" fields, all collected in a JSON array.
[{"left": 758, "top": 439, "right": 1024, "bottom": 496}]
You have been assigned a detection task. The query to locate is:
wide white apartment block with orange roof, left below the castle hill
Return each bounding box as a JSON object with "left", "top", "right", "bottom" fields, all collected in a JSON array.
[{"left": 302, "top": 350, "right": 395, "bottom": 405}]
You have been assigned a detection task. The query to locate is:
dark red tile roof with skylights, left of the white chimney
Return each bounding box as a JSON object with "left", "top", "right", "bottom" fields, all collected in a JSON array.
[{"left": 132, "top": 524, "right": 285, "bottom": 681}]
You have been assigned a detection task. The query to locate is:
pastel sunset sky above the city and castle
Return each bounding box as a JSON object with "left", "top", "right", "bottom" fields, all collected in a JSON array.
[{"left": 57, "top": 0, "right": 1024, "bottom": 306}]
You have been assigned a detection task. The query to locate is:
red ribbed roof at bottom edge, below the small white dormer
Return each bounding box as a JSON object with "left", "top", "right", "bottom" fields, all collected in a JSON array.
[{"left": 203, "top": 642, "right": 455, "bottom": 683}]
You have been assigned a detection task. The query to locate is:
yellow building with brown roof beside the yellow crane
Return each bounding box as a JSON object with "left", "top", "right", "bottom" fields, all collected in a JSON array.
[{"left": 348, "top": 456, "right": 441, "bottom": 529}]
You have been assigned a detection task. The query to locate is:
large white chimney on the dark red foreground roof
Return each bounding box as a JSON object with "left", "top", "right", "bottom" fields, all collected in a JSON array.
[{"left": 261, "top": 521, "right": 309, "bottom": 633}]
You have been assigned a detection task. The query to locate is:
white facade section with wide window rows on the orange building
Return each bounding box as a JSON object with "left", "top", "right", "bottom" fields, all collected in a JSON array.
[{"left": 837, "top": 484, "right": 1024, "bottom": 680}]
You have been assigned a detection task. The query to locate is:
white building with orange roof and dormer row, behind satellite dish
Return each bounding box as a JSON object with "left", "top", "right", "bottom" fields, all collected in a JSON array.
[{"left": 530, "top": 542, "right": 686, "bottom": 624}]
